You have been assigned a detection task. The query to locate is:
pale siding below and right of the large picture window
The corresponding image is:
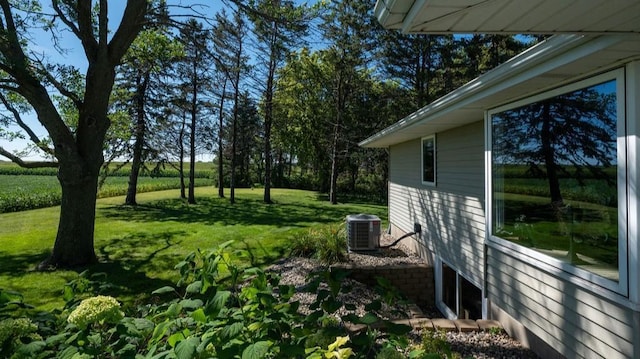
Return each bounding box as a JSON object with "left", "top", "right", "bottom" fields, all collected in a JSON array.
[{"left": 485, "top": 63, "right": 640, "bottom": 359}]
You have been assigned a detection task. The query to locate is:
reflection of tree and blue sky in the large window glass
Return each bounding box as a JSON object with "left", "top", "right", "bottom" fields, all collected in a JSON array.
[{"left": 492, "top": 81, "right": 617, "bottom": 280}]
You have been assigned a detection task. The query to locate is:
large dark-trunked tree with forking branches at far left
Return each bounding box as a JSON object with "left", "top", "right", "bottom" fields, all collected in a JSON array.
[{"left": 0, "top": 0, "right": 149, "bottom": 268}]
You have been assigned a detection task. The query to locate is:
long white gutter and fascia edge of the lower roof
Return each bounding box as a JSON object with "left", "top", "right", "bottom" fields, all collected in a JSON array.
[{"left": 358, "top": 35, "right": 623, "bottom": 147}]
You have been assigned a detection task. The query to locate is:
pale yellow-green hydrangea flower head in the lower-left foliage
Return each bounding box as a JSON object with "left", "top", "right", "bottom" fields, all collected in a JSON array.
[{"left": 67, "top": 295, "right": 124, "bottom": 329}]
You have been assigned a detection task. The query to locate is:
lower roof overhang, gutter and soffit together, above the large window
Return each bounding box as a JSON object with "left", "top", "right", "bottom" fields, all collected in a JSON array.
[{"left": 359, "top": 34, "right": 640, "bottom": 147}]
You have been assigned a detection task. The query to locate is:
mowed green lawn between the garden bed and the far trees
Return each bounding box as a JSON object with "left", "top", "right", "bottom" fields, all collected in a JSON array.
[{"left": 0, "top": 187, "right": 387, "bottom": 310}]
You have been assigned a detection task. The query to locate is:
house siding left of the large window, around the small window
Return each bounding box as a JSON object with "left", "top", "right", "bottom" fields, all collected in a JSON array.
[{"left": 389, "top": 121, "right": 485, "bottom": 286}]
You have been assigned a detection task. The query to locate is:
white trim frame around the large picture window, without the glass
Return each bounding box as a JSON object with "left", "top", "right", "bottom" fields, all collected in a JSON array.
[{"left": 485, "top": 68, "right": 637, "bottom": 297}]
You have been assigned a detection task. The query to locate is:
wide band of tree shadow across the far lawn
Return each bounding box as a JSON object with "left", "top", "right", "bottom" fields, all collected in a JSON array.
[{"left": 101, "top": 198, "right": 382, "bottom": 227}]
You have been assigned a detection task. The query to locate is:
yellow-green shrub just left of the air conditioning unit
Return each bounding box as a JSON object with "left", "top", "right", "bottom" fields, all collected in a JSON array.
[{"left": 291, "top": 225, "right": 347, "bottom": 264}]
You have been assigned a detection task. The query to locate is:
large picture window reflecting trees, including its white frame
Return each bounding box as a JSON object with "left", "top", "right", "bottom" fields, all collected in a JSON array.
[{"left": 489, "top": 71, "right": 626, "bottom": 289}]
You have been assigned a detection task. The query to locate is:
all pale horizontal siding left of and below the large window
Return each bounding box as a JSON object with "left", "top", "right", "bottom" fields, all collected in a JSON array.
[{"left": 389, "top": 121, "right": 640, "bottom": 358}]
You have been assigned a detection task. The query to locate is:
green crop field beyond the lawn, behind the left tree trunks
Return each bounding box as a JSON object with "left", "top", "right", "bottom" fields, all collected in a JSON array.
[{"left": 0, "top": 162, "right": 213, "bottom": 213}]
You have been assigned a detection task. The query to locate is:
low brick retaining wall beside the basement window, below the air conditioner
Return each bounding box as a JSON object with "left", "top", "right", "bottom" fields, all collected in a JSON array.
[{"left": 332, "top": 263, "right": 435, "bottom": 308}]
